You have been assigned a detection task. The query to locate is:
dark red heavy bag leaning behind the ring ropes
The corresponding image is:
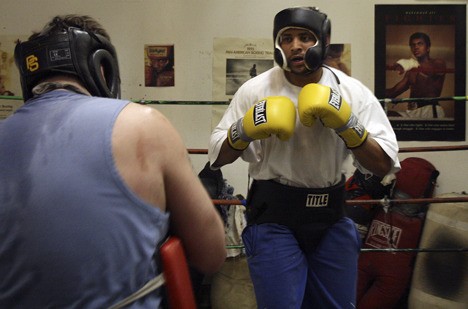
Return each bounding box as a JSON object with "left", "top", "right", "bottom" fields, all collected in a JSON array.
[{"left": 357, "top": 157, "right": 439, "bottom": 309}]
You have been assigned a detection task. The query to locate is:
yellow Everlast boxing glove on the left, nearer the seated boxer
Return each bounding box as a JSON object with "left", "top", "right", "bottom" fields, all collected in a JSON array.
[{"left": 228, "top": 96, "right": 296, "bottom": 150}]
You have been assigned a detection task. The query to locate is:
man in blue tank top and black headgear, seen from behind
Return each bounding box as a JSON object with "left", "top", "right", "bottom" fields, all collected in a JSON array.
[{"left": 0, "top": 15, "right": 226, "bottom": 308}]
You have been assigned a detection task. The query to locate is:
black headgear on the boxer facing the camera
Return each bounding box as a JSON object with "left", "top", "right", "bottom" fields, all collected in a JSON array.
[{"left": 273, "top": 7, "right": 331, "bottom": 71}]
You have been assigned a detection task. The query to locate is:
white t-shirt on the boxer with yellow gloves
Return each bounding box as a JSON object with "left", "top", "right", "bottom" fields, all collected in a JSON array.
[{"left": 208, "top": 67, "right": 400, "bottom": 188}]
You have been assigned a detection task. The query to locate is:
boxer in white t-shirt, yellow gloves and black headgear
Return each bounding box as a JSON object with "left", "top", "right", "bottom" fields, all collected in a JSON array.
[{"left": 208, "top": 7, "right": 399, "bottom": 309}]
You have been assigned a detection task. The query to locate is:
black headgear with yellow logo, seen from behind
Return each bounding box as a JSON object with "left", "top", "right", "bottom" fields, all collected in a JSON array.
[{"left": 15, "top": 27, "right": 120, "bottom": 101}]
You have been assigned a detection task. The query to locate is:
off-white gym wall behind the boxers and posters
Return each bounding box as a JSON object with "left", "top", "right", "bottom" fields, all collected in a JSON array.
[{"left": 0, "top": 0, "right": 468, "bottom": 195}]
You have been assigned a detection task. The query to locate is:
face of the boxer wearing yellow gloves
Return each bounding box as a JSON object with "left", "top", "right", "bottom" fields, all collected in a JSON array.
[{"left": 280, "top": 28, "right": 318, "bottom": 74}]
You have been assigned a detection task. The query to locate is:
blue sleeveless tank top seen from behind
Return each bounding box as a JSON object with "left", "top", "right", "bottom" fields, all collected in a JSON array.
[{"left": 0, "top": 90, "right": 169, "bottom": 308}]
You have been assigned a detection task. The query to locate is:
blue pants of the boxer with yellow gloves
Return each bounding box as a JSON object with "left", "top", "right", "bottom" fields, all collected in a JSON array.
[{"left": 242, "top": 218, "right": 361, "bottom": 309}]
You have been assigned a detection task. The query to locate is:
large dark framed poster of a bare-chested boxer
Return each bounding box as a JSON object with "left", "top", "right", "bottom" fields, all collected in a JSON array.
[{"left": 375, "top": 5, "right": 467, "bottom": 141}]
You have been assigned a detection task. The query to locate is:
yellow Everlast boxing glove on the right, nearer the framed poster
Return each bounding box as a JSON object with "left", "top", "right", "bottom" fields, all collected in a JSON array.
[{"left": 297, "top": 84, "right": 368, "bottom": 148}]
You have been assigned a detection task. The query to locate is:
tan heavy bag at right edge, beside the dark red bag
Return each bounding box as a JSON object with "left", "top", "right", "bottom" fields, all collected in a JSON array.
[{"left": 408, "top": 193, "right": 468, "bottom": 309}]
